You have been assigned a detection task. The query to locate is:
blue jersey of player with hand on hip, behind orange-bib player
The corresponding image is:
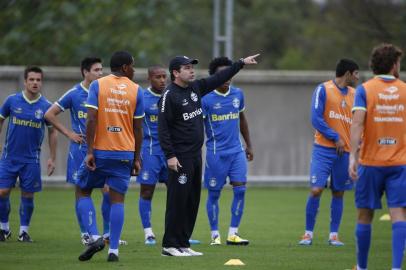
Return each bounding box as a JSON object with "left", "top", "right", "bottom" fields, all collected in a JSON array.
[{"left": 55, "top": 83, "right": 89, "bottom": 135}]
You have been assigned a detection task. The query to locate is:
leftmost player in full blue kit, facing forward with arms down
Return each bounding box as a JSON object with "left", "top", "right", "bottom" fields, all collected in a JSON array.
[{"left": 0, "top": 67, "right": 57, "bottom": 242}]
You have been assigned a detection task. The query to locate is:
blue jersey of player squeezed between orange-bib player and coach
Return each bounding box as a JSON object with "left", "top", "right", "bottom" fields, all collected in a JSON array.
[{"left": 142, "top": 88, "right": 163, "bottom": 155}]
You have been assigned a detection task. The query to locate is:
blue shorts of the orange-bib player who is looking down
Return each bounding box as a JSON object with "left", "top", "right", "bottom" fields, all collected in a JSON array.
[{"left": 310, "top": 145, "right": 353, "bottom": 191}]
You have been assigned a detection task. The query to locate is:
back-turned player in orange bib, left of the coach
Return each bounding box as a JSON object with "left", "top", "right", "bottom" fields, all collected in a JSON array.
[{"left": 76, "top": 51, "right": 144, "bottom": 262}]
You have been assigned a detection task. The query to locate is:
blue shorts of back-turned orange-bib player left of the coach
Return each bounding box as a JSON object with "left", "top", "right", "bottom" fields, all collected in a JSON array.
[{"left": 76, "top": 158, "right": 133, "bottom": 194}]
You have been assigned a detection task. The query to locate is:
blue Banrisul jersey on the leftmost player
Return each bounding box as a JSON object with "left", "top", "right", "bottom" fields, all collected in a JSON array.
[{"left": 0, "top": 92, "right": 51, "bottom": 163}]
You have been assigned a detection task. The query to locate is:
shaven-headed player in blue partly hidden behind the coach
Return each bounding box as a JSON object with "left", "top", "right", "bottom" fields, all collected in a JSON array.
[{"left": 137, "top": 66, "right": 200, "bottom": 245}]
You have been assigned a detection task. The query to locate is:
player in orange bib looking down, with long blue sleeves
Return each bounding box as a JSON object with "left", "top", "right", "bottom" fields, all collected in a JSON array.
[{"left": 299, "top": 59, "right": 359, "bottom": 246}]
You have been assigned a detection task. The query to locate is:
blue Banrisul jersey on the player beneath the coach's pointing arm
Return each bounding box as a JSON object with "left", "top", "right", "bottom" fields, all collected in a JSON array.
[{"left": 202, "top": 86, "right": 245, "bottom": 154}]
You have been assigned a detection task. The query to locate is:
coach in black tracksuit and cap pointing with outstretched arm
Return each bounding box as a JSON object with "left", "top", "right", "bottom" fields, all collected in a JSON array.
[{"left": 158, "top": 54, "right": 259, "bottom": 256}]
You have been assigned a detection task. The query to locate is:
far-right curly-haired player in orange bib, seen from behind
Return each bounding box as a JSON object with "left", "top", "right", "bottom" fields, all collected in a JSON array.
[{"left": 349, "top": 44, "right": 406, "bottom": 270}]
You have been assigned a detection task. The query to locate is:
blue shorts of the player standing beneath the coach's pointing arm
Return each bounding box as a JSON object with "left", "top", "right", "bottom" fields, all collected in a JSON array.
[{"left": 204, "top": 151, "right": 247, "bottom": 190}]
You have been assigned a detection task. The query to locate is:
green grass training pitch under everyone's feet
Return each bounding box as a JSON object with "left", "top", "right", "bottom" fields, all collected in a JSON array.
[{"left": 0, "top": 187, "right": 391, "bottom": 270}]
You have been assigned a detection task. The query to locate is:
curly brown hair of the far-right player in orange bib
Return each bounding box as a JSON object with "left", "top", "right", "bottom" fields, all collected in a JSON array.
[{"left": 369, "top": 43, "right": 403, "bottom": 75}]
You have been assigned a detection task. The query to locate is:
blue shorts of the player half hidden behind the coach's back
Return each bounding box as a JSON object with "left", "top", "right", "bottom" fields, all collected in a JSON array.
[{"left": 137, "top": 151, "right": 168, "bottom": 185}]
